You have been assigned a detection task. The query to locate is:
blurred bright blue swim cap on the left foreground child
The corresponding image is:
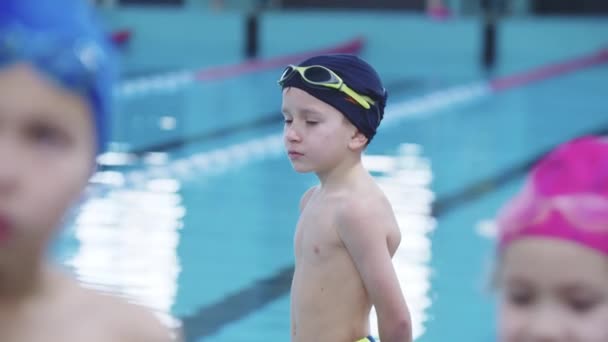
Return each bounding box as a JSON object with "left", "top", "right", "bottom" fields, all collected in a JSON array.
[{"left": 0, "top": 0, "right": 116, "bottom": 153}]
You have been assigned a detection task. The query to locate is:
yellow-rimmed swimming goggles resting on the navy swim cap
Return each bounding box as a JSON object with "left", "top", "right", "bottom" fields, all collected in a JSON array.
[{"left": 278, "top": 65, "right": 375, "bottom": 109}]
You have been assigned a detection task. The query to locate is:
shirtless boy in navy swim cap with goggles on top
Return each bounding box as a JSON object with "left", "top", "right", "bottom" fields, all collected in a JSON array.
[{"left": 279, "top": 55, "right": 412, "bottom": 342}]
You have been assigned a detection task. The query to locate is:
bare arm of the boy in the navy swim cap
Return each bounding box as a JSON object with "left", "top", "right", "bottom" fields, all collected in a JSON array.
[{"left": 337, "top": 200, "right": 412, "bottom": 342}]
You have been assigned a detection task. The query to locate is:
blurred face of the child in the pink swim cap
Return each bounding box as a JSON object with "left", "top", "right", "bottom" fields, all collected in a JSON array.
[{"left": 499, "top": 238, "right": 608, "bottom": 342}]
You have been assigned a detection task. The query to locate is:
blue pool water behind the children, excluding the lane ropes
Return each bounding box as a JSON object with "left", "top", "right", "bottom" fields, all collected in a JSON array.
[{"left": 56, "top": 8, "right": 608, "bottom": 342}]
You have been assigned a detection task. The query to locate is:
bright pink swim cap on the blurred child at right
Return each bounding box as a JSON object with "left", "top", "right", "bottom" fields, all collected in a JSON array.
[{"left": 497, "top": 136, "right": 608, "bottom": 256}]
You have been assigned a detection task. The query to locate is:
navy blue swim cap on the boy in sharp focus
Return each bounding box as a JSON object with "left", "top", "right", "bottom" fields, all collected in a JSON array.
[{"left": 282, "top": 54, "right": 388, "bottom": 141}]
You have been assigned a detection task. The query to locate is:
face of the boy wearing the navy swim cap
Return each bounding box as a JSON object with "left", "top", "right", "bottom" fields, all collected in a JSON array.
[{"left": 282, "top": 88, "right": 367, "bottom": 172}]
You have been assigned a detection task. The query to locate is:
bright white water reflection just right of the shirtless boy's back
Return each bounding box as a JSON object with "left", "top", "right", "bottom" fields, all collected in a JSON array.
[{"left": 363, "top": 144, "right": 435, "bottom": 339}]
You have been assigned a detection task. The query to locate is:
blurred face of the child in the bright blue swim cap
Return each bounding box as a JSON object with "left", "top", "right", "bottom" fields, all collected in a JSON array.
[{"left": 0, "top": 64, "right": 95, "bottom": 258}]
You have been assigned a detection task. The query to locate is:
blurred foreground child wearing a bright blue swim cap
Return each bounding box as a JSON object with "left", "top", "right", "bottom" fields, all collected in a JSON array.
[{"left": 0, "top": 0, "right": 176, "bottom": 342}]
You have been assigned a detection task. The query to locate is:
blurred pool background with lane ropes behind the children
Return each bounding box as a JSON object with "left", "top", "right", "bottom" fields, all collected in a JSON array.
[{"left": 53, "top": 0, "right": 608, "bottom": 342}]
